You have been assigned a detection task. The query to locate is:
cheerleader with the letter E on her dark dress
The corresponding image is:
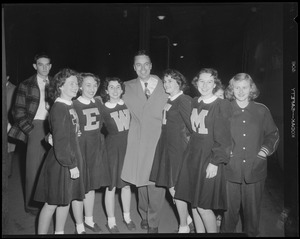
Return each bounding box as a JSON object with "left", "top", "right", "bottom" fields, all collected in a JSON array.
[{"left": 73, "top": 73, "right": 110, "bottom": 233}]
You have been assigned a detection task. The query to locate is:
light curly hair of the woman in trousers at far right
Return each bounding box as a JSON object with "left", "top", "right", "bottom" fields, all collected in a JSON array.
[{"left": 225, "top": 73, "right": 260, "bottom": 101}]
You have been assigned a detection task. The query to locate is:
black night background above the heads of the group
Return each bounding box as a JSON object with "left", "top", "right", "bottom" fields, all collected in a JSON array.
[{"left": 4, "top": 3, "right": 283, "bottom": 86}]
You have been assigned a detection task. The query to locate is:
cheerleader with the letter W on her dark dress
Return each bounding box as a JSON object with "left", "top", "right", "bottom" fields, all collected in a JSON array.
[{"left": 102, "top": 77, "right": 136, "bottom": 233}]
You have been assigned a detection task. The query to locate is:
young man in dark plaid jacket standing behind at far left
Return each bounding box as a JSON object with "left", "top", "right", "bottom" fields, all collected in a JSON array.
[{"left": 8, "top": 53, "right": 52, "bottom": 215}]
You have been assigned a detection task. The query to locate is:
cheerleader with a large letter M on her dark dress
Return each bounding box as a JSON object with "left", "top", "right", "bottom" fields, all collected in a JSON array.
[{"left": 175, "top": 68, "right": 231, "bottom": 233}]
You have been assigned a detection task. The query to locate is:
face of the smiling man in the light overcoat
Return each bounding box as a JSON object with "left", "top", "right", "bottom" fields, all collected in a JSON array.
[{"left": 133, "top": 55, "right": 152, "bottom": 80}]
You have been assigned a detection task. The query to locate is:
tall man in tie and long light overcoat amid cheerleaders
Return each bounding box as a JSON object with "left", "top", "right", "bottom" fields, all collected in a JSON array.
[{"left": 121, "top": 51, "right": 168, "bottom": 233}]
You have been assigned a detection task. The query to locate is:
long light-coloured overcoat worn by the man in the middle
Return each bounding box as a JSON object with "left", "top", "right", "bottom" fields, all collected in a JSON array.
[{"left": 121, "top": 76, "right": 168, "bottom": 187}]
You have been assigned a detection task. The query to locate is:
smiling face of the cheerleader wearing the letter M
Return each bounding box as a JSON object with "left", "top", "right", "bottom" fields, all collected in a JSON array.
[{"left": 197, "top": 73, "right": 216, "bottom": 99}]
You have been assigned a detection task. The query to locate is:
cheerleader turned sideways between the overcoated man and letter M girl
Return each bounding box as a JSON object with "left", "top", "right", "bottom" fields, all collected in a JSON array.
[{"left": 150, "top": 69, "right": 194, "bottom": 233}]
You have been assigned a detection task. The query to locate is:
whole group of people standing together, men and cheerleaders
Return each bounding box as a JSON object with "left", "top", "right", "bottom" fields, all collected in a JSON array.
[{"left": 9, "top": 51, "right": 279, "bottom": 236}]
